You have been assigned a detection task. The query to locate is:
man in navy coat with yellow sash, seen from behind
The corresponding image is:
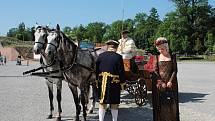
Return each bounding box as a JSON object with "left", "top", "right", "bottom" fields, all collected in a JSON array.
[{"left": 96, "top": 40, "right": 125, "bottom": 121}]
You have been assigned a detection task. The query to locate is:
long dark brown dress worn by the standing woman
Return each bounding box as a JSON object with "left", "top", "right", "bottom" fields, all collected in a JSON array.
[{"left": 152, "top": 55, "right": 180, "bottom": 121}]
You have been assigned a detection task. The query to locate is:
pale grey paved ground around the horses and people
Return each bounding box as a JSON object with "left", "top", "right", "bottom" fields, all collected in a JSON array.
[{"left": 0, "top": 62, "right": 215, "bottom": 121}]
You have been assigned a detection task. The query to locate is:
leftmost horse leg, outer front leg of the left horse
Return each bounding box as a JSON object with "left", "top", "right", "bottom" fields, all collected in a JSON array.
[{"left": 46, "top": 80, "right": 54, "bottom": 119}]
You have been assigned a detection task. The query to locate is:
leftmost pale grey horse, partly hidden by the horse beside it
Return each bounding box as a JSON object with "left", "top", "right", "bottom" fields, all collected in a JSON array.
[{"left": 33, "top": 25, "right": 63, "bottom": 120}]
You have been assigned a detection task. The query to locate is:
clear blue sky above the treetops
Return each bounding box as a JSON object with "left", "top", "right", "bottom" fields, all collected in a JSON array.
[{"left": 0, "top": 0, "right": 215, "bottom": 36}]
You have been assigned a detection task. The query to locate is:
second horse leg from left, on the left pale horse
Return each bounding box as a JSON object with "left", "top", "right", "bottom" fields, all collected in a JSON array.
[{"left": 56, "top": 80, "right": 62, "bottom": 121}]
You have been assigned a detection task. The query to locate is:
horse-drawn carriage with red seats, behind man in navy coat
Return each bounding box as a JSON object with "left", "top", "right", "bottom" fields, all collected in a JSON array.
[{"left": 123, "top": 51, "right": 153, "bottom": 106}]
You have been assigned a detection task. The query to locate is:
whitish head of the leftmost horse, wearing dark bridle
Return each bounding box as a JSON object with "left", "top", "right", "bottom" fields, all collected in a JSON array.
[{"left": 33, "top": 24, "right": 49, "bottom": 54}]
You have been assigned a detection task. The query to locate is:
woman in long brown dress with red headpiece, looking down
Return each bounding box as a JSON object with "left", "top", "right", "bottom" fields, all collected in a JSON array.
[{"left": 152, "top": 37, "right": 180, "bottom": 121}]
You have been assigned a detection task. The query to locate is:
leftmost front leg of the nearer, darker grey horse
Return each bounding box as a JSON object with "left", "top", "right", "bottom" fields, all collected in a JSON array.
[{"left": 68, "top": 83, "right": 81, "bottom": 121}]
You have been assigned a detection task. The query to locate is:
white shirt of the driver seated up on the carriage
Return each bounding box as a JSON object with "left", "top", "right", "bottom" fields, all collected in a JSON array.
[{"left": 117, "top": 37, "right": 136, "bottom": 59}]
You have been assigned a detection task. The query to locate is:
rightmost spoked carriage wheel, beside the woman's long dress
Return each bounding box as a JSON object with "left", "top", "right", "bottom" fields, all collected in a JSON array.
[{"left": 134, "top": 79, "right": 147, "bottom": 106}]
